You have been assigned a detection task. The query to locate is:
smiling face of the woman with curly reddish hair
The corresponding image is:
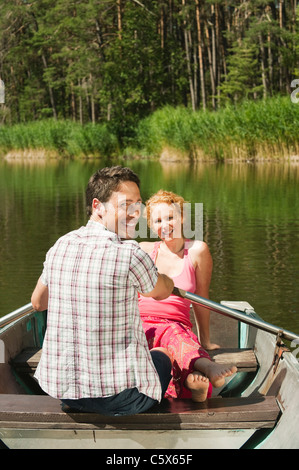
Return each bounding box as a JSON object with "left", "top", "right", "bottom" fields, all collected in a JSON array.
[{"left": 151, "top": 203, "right": 182, "bottom": 241}]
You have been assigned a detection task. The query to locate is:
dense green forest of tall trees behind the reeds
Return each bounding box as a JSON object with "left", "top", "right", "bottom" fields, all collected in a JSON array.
[{"left": 0, "top": 0, "right": 299, "bottom": 143}]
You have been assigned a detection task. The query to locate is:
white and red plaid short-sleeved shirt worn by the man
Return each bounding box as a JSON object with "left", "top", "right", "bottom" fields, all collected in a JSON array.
[{"left": 35, "top": 220, "right": 161, "bottom": 401}]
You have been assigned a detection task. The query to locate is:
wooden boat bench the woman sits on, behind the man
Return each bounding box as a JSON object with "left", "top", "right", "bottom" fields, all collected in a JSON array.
[{"left": 12, "top": 348, "right": 258, "bottom": 374}]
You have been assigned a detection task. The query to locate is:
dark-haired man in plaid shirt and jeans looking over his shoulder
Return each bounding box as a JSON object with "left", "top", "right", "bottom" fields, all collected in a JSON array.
[{"left": 31, "top": 166, "right": 173, "bottom": 415}]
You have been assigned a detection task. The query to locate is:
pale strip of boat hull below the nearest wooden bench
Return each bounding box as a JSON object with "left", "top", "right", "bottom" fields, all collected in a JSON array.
[{"left": 0, "top": 428, "right": 255, "bottom": 451}]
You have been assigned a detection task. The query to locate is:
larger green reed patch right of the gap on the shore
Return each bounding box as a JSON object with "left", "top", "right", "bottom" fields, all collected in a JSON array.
[{"left": 137, "top": 97, "right": 299, "bottom": 160}]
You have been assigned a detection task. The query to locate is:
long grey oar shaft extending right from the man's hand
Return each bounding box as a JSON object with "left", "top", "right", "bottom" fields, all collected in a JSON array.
[{"left": 172, "top": 287, "right": 299, "bottom": 341}]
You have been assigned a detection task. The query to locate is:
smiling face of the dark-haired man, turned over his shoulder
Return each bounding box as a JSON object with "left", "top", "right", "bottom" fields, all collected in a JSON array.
[{"left": 93, "top": 181, "right": 142, "bottom": 239}]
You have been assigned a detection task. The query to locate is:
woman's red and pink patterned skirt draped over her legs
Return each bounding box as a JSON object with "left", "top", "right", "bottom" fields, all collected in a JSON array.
[{"left": 142, "top": 316, "right": 212, "bottom": 398}]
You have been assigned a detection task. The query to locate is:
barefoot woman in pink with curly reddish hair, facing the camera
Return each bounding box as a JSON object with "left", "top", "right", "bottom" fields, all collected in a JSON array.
[{"left": 139, "top": 190, "right": 237, "bottom": 401}]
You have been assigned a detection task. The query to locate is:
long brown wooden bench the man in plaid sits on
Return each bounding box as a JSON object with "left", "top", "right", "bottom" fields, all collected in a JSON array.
[{"left": 0, "top": 394, "right": 280, "bottom": 431}]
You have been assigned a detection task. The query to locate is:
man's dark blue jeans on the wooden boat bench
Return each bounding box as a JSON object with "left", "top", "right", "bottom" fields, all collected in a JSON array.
[{"left": 61, "top": 351, "right": 172, "bottom": 416}]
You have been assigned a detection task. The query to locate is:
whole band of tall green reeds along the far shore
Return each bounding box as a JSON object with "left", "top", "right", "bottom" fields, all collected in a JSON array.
[{"left": 0, "top": 96, "right": 299, "bottom": 161}]
